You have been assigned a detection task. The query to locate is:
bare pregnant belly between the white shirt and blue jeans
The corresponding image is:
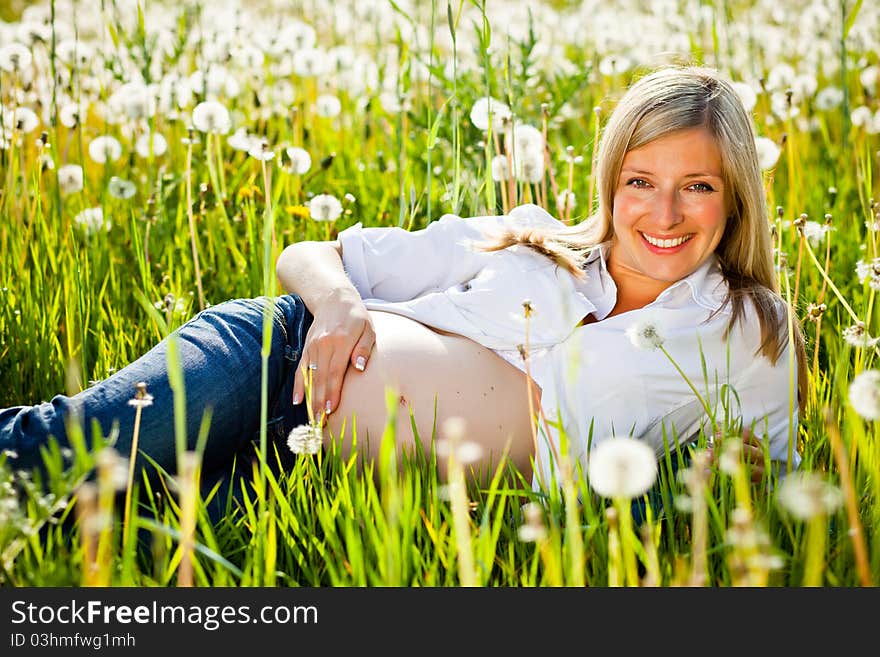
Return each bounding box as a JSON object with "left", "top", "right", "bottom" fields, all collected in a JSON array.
[{"left": 327, "top": 311, "right": 540, "bottom": 478}]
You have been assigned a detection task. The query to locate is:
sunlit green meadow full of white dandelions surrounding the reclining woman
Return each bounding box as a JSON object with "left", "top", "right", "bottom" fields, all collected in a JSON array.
[{"left": 0, "top": 0, "right": 880, "bottom": 586}]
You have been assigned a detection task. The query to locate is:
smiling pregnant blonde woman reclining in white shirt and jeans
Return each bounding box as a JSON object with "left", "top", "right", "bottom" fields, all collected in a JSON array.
[{"left": 0, "top": 67, "right": 806, "bottom": 516}]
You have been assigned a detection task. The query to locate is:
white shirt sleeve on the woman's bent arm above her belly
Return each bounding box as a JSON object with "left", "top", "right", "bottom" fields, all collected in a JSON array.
[{"left": 339, "top": 205, "right": 562, "bottom": 302}]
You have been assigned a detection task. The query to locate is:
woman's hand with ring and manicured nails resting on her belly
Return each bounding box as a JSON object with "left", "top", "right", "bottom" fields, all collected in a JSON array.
[{"left": 293, "top": 289, "right": 376, "bottom": 425}]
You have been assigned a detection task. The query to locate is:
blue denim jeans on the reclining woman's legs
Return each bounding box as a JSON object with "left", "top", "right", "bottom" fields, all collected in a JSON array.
[{"left": 0, "top": 295, "right": 312, "bottom": 516}]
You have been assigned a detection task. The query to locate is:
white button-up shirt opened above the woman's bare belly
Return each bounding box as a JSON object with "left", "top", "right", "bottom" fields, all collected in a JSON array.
[{"left": 339, "top": 205, "right": 800, "bottom": 486}]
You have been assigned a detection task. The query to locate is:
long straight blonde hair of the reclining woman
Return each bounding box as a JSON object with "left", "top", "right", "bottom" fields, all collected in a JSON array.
[{"left": 486, "top": 66, "right": 807, "bottom": 412}]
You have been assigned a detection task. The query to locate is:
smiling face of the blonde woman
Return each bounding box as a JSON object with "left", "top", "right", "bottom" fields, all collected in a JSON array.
[{"left": 609, "top": 128, "right": 728, "bottom": 299}]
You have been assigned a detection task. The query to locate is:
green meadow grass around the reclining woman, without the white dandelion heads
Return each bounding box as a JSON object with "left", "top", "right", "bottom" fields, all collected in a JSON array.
[{"left": 0, "top": 1, "right": 880, "bottom": 586}]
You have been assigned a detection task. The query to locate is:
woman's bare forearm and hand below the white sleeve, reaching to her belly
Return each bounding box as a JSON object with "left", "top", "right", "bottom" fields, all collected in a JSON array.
[{"left": 275, "top": 241, "right": 376, "bottom": 418}]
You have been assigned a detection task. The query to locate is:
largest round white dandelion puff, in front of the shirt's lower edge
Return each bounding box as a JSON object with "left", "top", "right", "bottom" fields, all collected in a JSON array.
[{"left": 588, "top": 436, "right": 657, "bottom": 499}]
